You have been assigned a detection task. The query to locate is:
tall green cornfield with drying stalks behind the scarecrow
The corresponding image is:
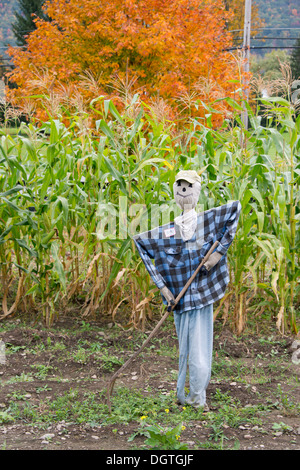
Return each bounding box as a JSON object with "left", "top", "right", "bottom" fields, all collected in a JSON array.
[{"left": 0, "top": 96, "right": 300, "bottom": 333}]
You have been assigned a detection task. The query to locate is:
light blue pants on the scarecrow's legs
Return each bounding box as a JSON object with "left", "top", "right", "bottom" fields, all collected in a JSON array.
[{"left": 174, "top": 304, "right": 213, "bottom": 406}]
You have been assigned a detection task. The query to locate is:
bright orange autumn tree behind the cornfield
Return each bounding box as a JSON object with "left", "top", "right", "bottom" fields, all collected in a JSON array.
[{"left": 9, "top": 0, "right": 237, "bottom": 125}]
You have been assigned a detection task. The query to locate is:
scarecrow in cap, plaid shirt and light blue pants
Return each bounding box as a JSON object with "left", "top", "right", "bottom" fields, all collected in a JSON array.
[{"left": 134, "top": 170, "right": 241, "bottom": 410}]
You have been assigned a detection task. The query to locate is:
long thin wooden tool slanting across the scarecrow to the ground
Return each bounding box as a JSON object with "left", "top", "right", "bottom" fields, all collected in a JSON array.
[{"left": 107, "top": 241, "right": 219, "bottom": 413}]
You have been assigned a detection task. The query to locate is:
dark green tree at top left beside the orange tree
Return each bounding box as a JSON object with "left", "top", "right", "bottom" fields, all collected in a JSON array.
[{"left": 12, "top": 0, "right": 47, "bottom": 46}]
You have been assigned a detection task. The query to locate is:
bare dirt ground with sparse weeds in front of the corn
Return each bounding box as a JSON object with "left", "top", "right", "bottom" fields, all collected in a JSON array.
[{"left": 0, "top": 312, "right": 300, "bottom": 450}]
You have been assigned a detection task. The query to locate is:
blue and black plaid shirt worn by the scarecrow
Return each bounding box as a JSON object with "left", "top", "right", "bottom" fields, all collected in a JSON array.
[{"left": 134, "top": 201, "right": 241, "bottom": 313}]
